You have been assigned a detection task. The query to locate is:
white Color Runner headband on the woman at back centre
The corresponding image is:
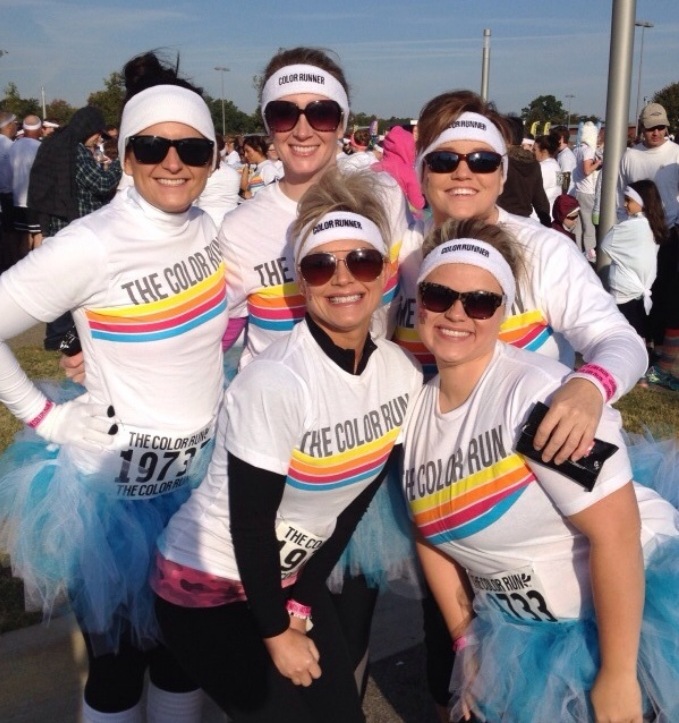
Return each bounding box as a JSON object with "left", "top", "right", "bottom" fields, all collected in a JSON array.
[{"left": 262, "top": 65, "right": 349, "bottom": 133}]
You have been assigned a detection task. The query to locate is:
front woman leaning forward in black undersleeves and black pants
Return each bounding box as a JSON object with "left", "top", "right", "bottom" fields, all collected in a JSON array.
[{"left": 153, "top": 171, "right": 422, "bottom": 723}]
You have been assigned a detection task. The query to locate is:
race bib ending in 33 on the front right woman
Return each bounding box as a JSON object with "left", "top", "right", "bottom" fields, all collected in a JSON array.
[{"left": 467, "top": 565, "right": 557, "bottom": 623}]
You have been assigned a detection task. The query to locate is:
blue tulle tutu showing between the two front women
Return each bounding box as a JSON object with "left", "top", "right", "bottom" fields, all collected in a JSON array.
[{"left": 328, "top": 465, "right": 422, "bottom": 597}]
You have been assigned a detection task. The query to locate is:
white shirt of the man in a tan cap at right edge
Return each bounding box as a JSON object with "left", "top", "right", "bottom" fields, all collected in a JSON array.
[{"left": 618, "top": 139, "right": 679, "bottom": 223}]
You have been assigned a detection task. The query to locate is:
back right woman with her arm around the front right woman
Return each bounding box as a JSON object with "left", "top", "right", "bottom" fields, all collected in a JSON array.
[{"left": 396, "top": 91, "right": 647, "bottom": 723}]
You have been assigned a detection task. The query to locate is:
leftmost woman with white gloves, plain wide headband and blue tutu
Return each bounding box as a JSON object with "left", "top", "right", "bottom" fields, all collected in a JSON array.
[{"left": 0, "top": 56, "right": 226, "bottom": 723}]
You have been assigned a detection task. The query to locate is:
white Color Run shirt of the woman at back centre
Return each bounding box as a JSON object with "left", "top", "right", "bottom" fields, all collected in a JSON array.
[{"left": 218, "top": 174, "right": 407, "bottom": 367}]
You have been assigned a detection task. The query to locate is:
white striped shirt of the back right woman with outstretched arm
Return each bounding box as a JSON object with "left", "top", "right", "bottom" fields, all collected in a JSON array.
[{"left": 394, "top": 204, "right": 647, "bottom": 400}]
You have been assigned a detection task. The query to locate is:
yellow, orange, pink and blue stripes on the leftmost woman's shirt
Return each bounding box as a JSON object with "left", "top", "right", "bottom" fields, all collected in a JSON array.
[{"left": 85, "top": 264, "right": 226, "bottom": 343}]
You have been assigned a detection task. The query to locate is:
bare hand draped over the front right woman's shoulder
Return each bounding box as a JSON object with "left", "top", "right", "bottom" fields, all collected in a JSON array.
[{"left": 534, "top": 377, "right": 604, "bottom": 464}]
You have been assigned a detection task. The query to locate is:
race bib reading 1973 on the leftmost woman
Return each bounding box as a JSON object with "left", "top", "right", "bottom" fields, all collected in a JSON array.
[{"left": 114, "top": 424, "right": 214, "bottom": 499}]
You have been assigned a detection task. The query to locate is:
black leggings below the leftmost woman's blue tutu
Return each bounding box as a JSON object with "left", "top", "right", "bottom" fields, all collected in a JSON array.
[{"left": 83, "top": 633, "right": 198, "bottom": 713}]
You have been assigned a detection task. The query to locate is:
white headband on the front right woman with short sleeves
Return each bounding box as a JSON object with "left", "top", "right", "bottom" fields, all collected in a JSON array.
[{"left": 417, "top": 238, "right": 516, "bottom": 316}]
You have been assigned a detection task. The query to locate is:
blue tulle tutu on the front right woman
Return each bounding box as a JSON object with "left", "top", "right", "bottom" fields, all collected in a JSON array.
[{"left": 451, "top": 538, "right": 679, "bottom": 723}]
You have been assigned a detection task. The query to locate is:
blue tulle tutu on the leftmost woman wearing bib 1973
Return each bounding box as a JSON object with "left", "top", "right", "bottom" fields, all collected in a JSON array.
[{"left": 0, "top": 389, "right": 211, "bottom": 654}]
